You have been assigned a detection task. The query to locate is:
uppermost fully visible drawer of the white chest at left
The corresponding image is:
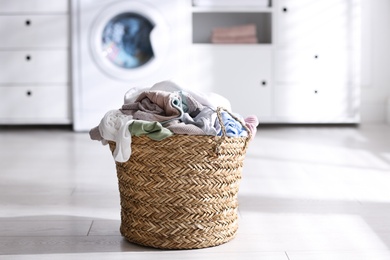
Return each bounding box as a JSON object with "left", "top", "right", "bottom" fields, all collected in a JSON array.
[{"left": 0, "top": 15, "right": 69, "bottom": 49}]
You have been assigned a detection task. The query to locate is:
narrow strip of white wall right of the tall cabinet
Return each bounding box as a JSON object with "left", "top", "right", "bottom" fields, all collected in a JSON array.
[{"left": 361, "top": 0, "right": 390, "bottom": 123}]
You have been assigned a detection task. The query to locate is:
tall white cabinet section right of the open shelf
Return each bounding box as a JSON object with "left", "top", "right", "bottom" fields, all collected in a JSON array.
[{"left": 273, "top": 0, "right": 359, "bottom": 123}]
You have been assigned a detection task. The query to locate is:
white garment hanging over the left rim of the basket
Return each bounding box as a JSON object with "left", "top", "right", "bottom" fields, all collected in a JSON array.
[{"left": 98, "top": 110, "right": 134, "bottom": 162}]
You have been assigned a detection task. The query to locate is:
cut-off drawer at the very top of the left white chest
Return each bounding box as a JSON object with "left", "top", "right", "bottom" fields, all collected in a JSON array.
[{"left": 0, "top": 0, "right": 69, "bottom": 14}]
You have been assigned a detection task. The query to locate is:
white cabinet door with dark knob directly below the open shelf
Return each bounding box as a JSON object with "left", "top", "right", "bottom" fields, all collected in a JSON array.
[{"left": 193, "top": 46, "right": 272, "bottom": 118}]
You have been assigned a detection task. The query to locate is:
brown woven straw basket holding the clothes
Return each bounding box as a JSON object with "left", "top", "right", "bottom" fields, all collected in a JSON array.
[{"left": 110, "top": 106, "right": 250, "bottom": 249}]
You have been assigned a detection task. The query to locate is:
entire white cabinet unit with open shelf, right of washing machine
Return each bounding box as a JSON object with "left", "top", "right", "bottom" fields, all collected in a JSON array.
[{"left": 192, "top": 0, "right": 360, "bottom": 123}]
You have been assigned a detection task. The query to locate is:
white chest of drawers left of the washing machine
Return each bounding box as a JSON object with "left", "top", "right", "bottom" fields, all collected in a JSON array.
[{"left": 0, "top": 0, "right": 71, "bottom": 124}]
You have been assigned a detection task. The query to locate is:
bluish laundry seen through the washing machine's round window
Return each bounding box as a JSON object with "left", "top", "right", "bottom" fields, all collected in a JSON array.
[{"left": 102, "top": 13, "right": 154, "bottom": 69}]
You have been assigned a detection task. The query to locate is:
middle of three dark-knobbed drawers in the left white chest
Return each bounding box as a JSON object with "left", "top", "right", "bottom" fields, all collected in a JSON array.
[{"left": 0, "top": 50, "right": 69, "bottom": 84}]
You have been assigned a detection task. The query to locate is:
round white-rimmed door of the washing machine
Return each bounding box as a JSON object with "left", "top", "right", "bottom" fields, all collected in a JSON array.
[{"left": 90, "top": 1, "right": 171, "bottom": 80}]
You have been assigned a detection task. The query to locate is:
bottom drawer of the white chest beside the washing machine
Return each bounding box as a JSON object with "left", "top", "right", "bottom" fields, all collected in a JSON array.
[{"left": 0, "top": 85, "right": 70, "bottom": 123}]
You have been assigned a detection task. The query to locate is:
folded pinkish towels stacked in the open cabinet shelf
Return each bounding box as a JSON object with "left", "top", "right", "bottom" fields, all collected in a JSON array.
[{"left": 211, "top": 24, "right": 258, "bottom": 44}]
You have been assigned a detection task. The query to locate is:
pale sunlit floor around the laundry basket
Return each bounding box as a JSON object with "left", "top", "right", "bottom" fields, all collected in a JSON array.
[{"left": 0, "top": 125, "right": 390, "bottom": 260}]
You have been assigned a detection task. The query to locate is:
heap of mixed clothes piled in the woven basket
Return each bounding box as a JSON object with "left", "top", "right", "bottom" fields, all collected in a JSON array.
[{"left": 89, "top": 81, "right": 258, "bottom": 162}]
